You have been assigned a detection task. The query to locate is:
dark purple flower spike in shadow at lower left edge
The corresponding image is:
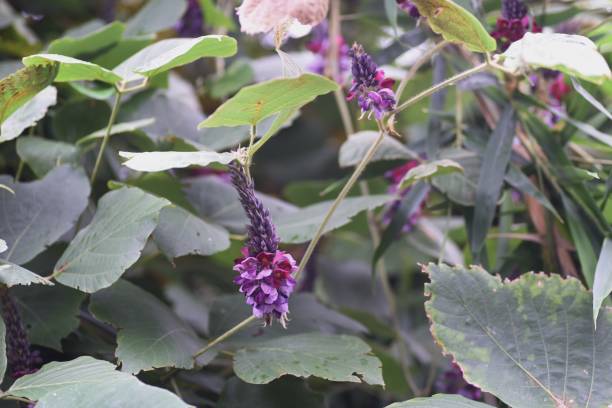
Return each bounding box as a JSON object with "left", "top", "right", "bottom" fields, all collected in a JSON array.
[{"left": 1, "top": 290, "right": 41, "bottom": 379}]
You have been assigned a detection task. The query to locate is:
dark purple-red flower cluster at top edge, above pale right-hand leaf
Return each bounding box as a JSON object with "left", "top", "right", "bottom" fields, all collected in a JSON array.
[{"left": 491, "top": 0, "right": 542, "bottom": 50}]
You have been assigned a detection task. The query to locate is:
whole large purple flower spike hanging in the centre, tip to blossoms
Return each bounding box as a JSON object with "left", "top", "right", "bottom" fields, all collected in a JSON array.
[{"left": 230, "top": 165, "right": 297, "bottom": 327}]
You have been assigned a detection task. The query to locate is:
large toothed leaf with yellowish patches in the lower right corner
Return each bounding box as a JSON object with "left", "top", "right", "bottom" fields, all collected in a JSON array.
[{"left": 425, "top": 264, "right": 612, "bottom": 408}]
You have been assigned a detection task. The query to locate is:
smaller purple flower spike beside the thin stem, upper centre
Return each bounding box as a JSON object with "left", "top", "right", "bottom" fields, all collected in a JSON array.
[{"left": 347, "top": 44, "right": 396, "bottom": 119}]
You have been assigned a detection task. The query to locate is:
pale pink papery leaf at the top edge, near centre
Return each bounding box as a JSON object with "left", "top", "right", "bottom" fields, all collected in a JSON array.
[{"left": 237, "top": 0, "right": 329, "bottom": 34}]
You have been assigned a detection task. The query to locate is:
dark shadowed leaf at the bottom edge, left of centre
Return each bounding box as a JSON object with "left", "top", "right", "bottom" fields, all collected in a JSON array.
[{"left": 217, "top": 377, "right": 325, "bottom": 408}]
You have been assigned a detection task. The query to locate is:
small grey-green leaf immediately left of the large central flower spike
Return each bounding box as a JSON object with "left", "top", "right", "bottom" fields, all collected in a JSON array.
[{"left": 153, "top": 207, "right": 230, "bottom": 259}]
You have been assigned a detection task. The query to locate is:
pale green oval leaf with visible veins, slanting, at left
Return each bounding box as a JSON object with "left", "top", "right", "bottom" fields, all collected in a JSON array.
[{"left": 53, "top": 187, "right": 169, "bottom": 293}]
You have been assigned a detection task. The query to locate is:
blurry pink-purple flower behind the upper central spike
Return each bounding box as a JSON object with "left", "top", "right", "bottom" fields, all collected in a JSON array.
[{"left": 306, "top": 21, "right": 350, "bottom": 83}]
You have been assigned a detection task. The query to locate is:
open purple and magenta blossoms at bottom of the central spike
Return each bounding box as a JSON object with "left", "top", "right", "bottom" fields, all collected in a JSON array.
[{"left": 234, "top": 248, "right": 297, "bottom": 327}]
